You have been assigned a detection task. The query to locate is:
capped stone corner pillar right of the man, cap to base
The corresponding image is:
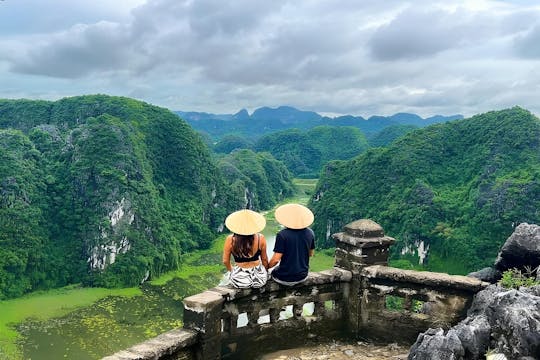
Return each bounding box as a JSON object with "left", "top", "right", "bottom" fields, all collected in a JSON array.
[{"left": 332, "top": 219, "right": 395, "bottom": 338}]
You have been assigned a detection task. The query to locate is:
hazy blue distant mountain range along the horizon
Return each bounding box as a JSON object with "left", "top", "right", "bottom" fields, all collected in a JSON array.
[{"left": 175, "top": 106, "right": 463, "bottom": 138}]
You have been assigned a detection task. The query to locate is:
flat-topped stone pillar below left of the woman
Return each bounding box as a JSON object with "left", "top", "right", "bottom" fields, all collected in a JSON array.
[{"left": 183, "top": 291, "right": 224, "bottom": 360}]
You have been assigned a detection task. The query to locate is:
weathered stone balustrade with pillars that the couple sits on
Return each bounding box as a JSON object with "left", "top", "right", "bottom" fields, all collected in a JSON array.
[{"left": 105, "top": 220, "right": 488, "bottom": 360}]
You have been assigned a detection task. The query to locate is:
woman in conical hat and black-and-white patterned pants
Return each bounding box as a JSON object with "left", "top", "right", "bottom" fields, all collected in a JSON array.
[{"left": 223, "top": 209, "right": 268, "bottom": 288}]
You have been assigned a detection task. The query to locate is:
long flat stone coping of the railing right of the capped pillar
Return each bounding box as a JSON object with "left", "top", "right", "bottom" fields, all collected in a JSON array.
[{"left": 360, "top": 265, "right": 489, "bottom": 292}]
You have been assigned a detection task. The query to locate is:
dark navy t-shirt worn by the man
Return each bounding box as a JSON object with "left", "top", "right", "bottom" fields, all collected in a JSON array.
[{"left": 272, "top": 228, "right": 315, "bottom": 282}]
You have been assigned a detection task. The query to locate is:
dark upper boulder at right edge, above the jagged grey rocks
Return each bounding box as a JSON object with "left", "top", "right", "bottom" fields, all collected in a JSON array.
[{"left": 495, "top": 223, "right": 540, "bottom": 271}]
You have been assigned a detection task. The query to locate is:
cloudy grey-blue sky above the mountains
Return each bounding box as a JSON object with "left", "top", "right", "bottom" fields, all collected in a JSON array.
[{"left": 0, "top": 0, "right": 540, "bottom": 117}]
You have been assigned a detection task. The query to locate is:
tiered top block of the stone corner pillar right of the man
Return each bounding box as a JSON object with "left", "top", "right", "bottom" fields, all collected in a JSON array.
[{"left": 332, "top": 219, "right": 396, "bottom": 272}]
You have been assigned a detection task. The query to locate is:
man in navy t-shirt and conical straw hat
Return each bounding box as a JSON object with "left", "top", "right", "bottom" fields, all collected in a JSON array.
[{"left": 268, "top": 204, "right": 315, "bottom": 286}]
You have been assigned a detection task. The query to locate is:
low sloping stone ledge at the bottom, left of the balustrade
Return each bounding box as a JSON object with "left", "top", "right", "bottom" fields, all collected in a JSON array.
[{"left": 102, "top": 329, "right": 197, "bottom": 360}]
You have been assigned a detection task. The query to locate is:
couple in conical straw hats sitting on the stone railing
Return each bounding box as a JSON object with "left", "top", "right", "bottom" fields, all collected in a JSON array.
[{"left": 223, "top": 204, "right": 315, "bottom": 288}]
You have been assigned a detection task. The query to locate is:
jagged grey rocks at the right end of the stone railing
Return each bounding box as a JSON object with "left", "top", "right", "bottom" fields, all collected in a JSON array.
[{"left": 409, "top": 223, "right": 540, "bottom": 360}]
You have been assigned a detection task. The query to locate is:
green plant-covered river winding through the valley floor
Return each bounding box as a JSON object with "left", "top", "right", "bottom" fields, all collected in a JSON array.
[{"left": 0, "top": 175, "right": 334, "bottom": 359}]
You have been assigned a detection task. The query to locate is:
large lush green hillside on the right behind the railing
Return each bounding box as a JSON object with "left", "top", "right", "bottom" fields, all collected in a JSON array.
[{"left": 310, "top": 107, "right": 540, "bottom": 273}]
